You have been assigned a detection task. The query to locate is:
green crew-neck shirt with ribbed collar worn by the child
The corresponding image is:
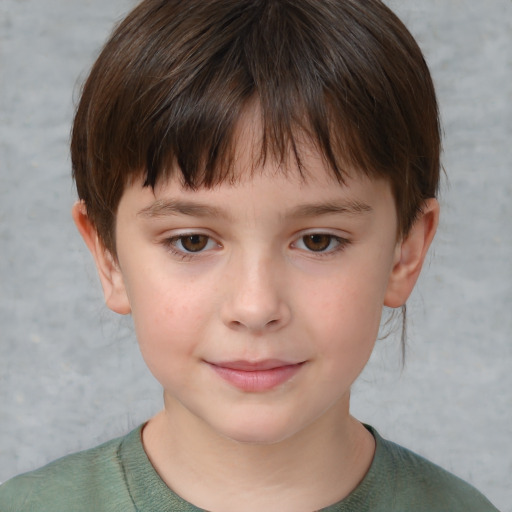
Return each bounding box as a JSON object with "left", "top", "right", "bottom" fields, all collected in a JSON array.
[{"left": 0, "top": 427, "right": 497, "bottom": 512}]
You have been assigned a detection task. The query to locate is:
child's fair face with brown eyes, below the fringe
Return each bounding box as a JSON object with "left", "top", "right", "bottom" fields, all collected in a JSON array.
[{"left": 105, "top": 142, "right": 408, "bottom": 442}]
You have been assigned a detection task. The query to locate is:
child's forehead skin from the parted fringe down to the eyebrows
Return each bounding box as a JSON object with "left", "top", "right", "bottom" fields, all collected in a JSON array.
[{"left": 121, "top": 104, "right": 391, "bottom": 218}]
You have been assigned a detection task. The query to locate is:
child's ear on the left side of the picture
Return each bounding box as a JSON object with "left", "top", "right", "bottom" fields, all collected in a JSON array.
[{"left": 71, "top": 201, "right": 131, "bottom": 315}]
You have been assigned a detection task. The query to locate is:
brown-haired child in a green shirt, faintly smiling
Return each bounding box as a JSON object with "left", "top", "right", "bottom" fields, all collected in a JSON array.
[{"left": 0, "top": 0, "right": 496, "bottom": 512}]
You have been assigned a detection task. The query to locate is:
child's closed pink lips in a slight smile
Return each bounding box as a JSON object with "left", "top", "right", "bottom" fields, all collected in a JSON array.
[{"left": 208, "top": 359, "right": 305, "bottom": 393}]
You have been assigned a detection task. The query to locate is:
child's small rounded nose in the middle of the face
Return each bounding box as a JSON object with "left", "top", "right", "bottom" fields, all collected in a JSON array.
[{"left": 222, "top": 251, "right": 291, "bottom": 334}]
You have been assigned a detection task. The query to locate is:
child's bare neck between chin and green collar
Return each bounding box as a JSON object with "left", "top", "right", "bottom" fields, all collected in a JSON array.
[{"left": 143, "top": 396, "right": 374, "bottom": 512}]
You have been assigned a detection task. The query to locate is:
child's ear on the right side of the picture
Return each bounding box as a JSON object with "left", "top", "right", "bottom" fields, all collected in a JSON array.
[{"left": 384, "top": 199, "right": 439, "bottom": 308}]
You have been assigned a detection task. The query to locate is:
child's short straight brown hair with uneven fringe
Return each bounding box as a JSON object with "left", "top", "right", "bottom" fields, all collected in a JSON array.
[{"left": 71, "top": 0, "right": 440, "bottom": 254}]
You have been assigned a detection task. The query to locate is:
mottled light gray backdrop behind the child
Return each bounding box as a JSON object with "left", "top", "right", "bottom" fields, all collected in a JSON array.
[{"left": 0, "top": 0, "right": 512, "bottom": 512}]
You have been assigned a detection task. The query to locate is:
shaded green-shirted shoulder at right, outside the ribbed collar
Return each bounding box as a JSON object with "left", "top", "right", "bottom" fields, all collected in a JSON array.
[{"left": 371, "top": 429, "right": 497, "bottom": 512}]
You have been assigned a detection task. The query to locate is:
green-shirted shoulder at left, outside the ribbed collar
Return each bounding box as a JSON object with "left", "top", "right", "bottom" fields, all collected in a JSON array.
[{"left": 0, "top": 429, "right": 140, "bottom": 512}]
